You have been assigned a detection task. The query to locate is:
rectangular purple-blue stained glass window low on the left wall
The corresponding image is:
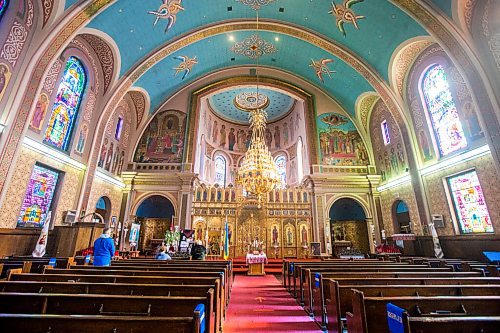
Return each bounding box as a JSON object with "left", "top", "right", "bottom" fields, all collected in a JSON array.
[{"left": 17, "top": 164, "right": 59, "bottom": 228}]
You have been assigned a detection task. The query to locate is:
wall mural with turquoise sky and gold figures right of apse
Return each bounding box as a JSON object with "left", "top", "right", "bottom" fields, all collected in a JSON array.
[{"left": 316, "top": 113, "right": 369, "bottom": 166}]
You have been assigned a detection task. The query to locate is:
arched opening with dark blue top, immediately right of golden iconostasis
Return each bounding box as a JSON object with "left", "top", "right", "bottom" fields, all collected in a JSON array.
[{"left": 329, "top": 198, "right": 370, "bottom": 255}]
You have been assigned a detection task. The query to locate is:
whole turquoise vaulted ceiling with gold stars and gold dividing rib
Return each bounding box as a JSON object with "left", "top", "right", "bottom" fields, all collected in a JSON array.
[{"left": 70, "top": 0, "right": 442, "bottom": 120}]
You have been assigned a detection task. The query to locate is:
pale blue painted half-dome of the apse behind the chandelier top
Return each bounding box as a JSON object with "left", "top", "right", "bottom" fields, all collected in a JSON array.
[{"left": 208, "top": 85, "right": 295, "bottom": 124}]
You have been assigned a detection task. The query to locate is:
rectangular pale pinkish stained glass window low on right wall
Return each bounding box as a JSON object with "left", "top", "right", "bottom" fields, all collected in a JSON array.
[{"left": 448, "top": 171, "right": 493, "bottom": 234}]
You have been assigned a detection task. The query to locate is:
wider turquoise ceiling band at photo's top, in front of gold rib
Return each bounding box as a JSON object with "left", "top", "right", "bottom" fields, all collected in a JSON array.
[{"left": 88, "top": 0, "right": 427, "bottom": 79}]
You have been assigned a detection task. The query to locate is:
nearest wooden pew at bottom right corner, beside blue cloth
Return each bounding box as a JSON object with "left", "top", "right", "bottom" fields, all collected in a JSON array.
[{"left": 403, "top": 314, "right": 500, "bottom": 333}]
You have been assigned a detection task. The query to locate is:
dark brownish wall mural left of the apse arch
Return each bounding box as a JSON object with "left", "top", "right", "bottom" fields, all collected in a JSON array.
[{"left": 134, "top": 110, "right": 186, "bottom": 163}]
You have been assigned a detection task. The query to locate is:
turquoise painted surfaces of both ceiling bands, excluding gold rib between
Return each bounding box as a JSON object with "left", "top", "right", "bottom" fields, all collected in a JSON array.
[{"left": 74, "top": 0, "right": 427, "bottom": 114}]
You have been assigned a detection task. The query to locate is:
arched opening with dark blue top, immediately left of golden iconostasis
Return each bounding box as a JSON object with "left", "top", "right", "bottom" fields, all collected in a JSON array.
[{"left": 135, "top": 195, "right": 175, "bottom": 253}]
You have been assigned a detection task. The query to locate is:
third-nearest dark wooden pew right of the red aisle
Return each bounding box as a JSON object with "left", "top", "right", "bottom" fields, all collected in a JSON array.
[{"left": 324, "top": 279, "right": 500, "bottom": 332}]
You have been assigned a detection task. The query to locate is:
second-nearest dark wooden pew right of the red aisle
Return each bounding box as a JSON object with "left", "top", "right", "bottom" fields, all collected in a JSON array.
[{"left": 347, "top": 289, "right": 500, "bottom": 333}]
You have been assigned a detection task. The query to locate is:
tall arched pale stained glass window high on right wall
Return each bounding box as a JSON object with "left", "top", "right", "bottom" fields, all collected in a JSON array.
[{"left": 422, "top": 65, "right": 467, "bottom": 156}]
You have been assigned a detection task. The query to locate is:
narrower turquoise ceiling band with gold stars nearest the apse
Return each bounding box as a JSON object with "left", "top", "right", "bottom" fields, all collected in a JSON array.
[{"left": 131, "top": 26, "right": 373, "bottom": 115}]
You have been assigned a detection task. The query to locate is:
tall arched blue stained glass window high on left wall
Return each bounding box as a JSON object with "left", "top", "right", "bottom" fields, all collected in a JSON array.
[{"left": 44, "top": 57, "right": 87, "bottom": 150}]
